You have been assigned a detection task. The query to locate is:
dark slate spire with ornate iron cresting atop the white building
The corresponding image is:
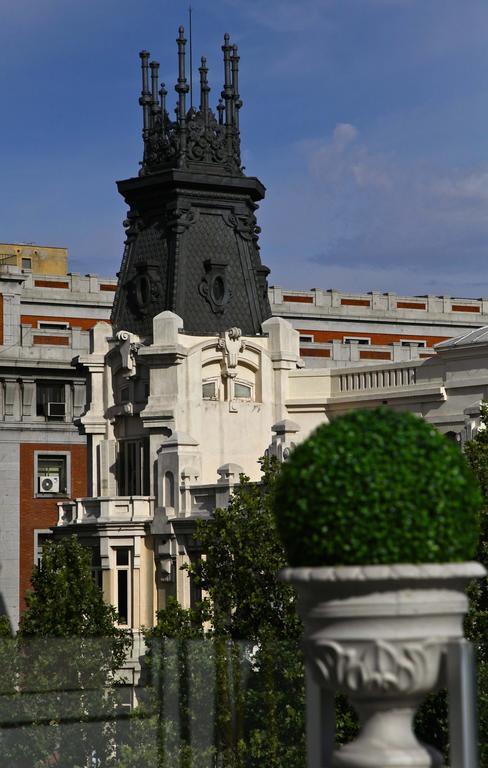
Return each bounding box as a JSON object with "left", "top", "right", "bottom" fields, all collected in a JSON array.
[{"left": 112, "top": 27, "right": 271, "bottom": 340}]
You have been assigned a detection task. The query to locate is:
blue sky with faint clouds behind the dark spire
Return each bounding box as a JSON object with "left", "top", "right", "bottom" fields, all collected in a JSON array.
[{"left": 0, "top": 0, "right": 488, "bottom": 297}]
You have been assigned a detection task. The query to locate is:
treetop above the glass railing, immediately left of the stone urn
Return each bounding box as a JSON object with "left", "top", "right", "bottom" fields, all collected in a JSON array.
[{"left": 190, "top": 459, "right": 301, "bottom": 641}]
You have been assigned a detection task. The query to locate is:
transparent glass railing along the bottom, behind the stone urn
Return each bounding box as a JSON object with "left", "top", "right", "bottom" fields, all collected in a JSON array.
[{"left": 0, "top": 638, "right": 488, "bottom": 768}]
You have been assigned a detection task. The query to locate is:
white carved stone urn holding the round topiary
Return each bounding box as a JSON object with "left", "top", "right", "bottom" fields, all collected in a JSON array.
[{"left": 280, "top": 562, "right": 486, "bottom": 768}]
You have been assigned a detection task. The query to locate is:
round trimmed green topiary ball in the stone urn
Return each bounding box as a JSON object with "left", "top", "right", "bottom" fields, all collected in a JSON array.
[{"left": 274, "top": 408, "right": 482, "bottom": 566}]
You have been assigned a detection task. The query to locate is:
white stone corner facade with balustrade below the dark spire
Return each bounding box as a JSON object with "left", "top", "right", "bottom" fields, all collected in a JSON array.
[{"left": 63, "top": 312, "right": 488, "bottom": 629}]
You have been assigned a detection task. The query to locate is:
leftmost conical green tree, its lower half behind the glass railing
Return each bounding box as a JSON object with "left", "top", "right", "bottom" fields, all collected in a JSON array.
[{"left": 10, "top": 537, "right": 131, "bottom": 768}]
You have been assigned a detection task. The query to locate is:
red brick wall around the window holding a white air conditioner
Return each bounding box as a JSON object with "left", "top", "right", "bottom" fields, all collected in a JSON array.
[{"left": 19, "top": 443, "right": 87, "bottom": 612}]
